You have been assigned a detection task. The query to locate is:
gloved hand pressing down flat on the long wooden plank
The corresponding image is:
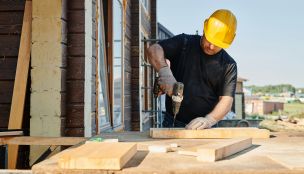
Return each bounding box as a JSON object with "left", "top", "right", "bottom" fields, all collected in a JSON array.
[{"left": 186, "top": 115, "right": 217, "bottom": 130}]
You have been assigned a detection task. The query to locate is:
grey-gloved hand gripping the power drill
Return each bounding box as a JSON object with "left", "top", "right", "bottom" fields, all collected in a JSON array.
[{"left": 158, "top": 66, "right": 176, "bottom": 96}]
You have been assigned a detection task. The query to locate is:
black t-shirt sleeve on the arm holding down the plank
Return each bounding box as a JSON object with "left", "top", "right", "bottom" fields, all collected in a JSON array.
[{"left": 222, "top": 62, "right": 237, "bottom": 97}]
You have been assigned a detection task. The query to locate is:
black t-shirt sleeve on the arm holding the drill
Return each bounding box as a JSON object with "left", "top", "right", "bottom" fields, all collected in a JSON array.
[{"left": 158, "top": 34, "right": 186, "bottom": 61}]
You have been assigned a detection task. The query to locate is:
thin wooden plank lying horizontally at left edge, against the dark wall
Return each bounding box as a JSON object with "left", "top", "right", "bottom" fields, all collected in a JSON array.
[{"left": 0, "top": 136, "right": 86, "bottom": 146}]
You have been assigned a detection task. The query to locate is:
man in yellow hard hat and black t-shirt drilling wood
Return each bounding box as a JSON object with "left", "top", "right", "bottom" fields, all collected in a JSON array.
[{"left": 148, "top": 10, "right": 237, "bottom": 129}]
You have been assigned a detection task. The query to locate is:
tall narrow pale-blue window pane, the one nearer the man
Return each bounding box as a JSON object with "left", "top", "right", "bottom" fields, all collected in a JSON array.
[{"left": 112, "top": 0, "right": 123, "bottom": 127}]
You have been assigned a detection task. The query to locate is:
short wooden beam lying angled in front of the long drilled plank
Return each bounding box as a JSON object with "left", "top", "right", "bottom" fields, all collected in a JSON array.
[{"left": 178, "top": 138, "right": 252, "bottom": 162}]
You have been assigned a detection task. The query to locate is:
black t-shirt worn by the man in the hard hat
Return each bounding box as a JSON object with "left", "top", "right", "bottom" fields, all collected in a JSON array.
[{"left": 159, "top": 34, "right": 237, "bottom": 124}]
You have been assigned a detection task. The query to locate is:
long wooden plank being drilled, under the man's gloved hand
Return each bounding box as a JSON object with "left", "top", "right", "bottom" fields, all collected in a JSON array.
[{"left": 150, "top": 127, "right": 270, "bottom": 138}]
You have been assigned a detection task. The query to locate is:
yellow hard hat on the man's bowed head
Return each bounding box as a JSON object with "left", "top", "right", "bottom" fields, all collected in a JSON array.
[{"left": 204, "top": 9, "right": 237, "bottom": 48}]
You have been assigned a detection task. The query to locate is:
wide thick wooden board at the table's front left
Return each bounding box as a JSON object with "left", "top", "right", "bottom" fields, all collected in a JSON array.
[{"left": 58, "top": 142, "right": 137, "bottom": 170}]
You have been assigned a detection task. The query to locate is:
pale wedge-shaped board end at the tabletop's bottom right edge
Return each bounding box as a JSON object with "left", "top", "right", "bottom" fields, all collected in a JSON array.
[{"left": 267, "top": 152, "right": 304, "bottom": 170}]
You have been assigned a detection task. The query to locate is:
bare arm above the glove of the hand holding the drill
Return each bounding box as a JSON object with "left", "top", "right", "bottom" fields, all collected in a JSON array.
[{"left": 147, "top": 44, "right": 168, "bottom": 72}]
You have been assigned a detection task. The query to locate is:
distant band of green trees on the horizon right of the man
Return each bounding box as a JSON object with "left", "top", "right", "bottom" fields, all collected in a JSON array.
[{"left": 247, "top": 84, "right": 296, "bottom": 94}]
